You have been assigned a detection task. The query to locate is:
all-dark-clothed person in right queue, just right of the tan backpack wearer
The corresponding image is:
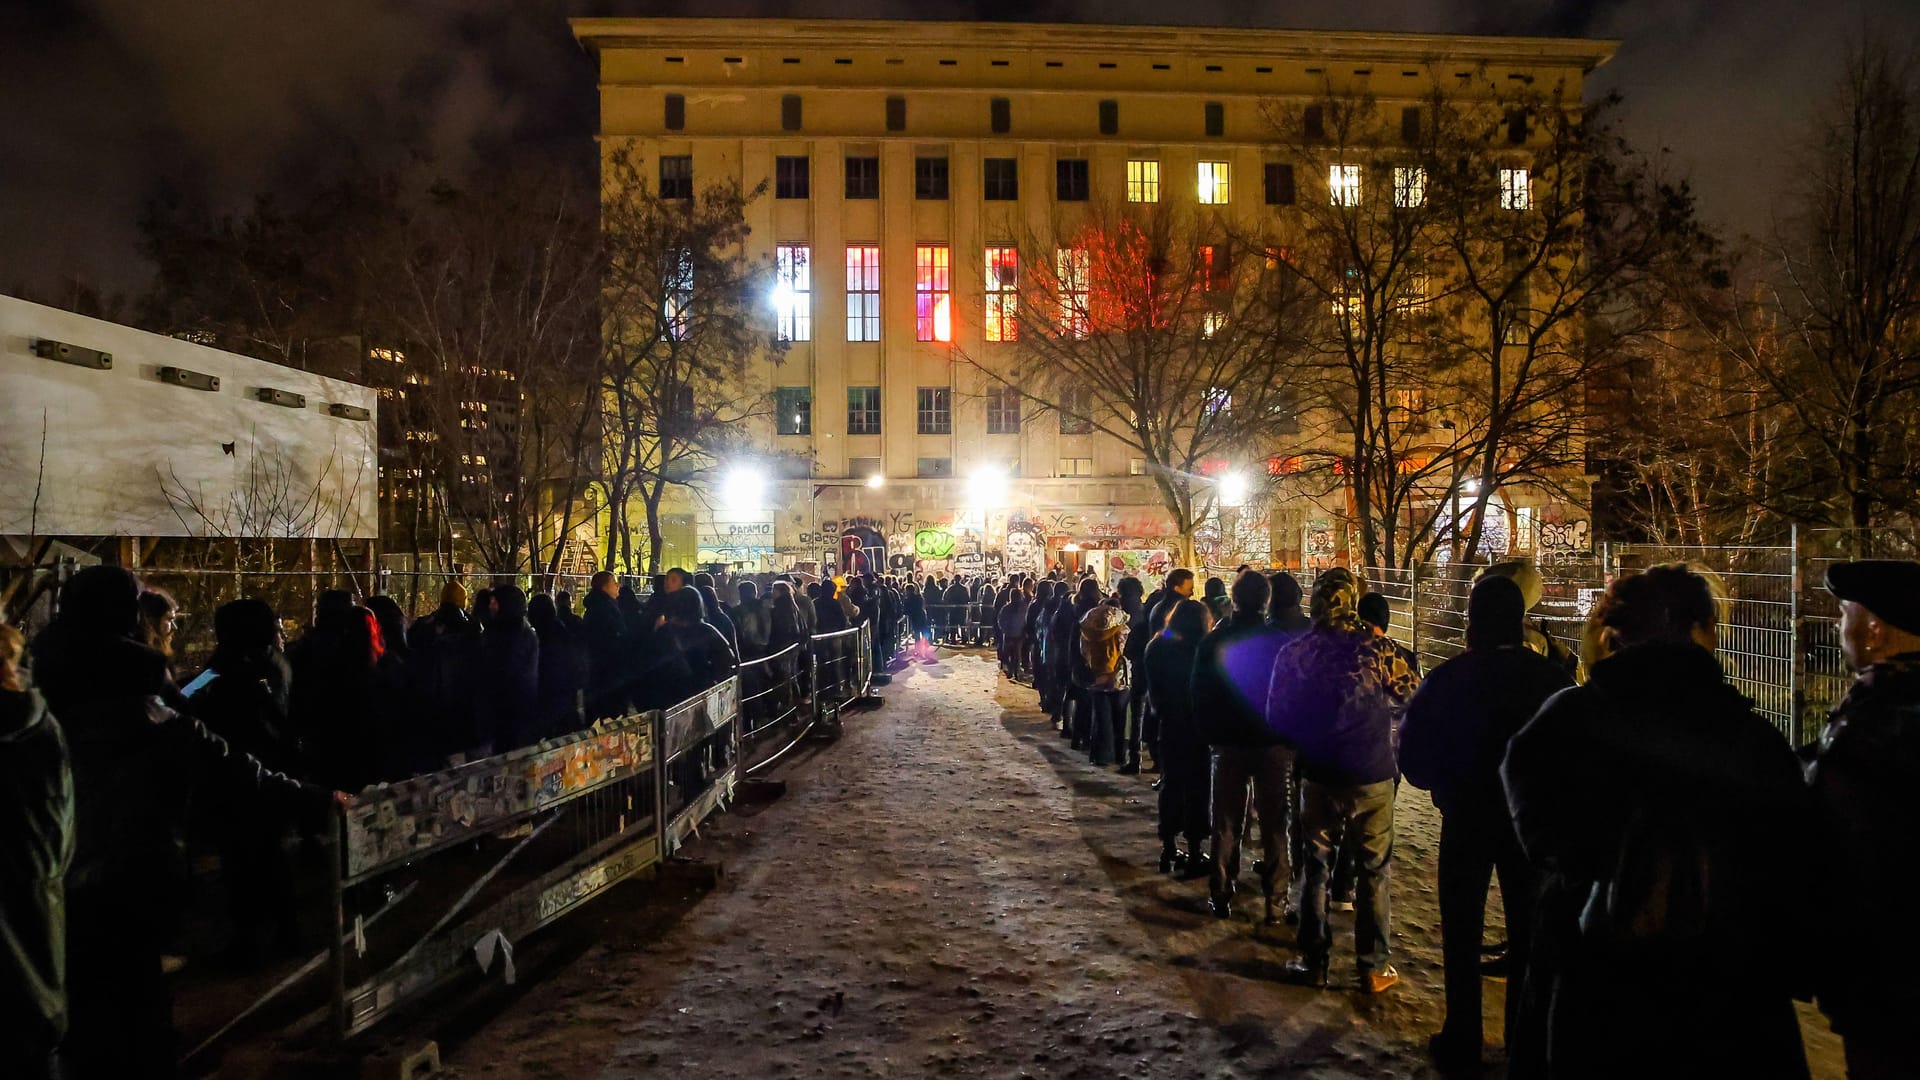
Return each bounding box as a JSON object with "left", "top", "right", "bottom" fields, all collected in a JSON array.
[{"left": 1140, "top": 601, "right": 1213, "bottom": 874}]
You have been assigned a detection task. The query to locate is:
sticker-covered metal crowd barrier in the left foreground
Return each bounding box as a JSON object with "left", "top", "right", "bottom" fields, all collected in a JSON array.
[{"left": 330, "top": 678, "right": 739, "bottom": 1038}]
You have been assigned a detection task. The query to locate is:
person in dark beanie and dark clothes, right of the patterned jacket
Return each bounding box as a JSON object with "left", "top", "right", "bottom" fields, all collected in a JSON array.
[{"left": 1400, "top": 577, "right": 1572, "bottom": 1072}]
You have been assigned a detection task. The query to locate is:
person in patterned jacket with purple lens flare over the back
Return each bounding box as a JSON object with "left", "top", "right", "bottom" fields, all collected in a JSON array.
[{"left": 1267, "top": 567, "right": 1419, "bottom": 994}]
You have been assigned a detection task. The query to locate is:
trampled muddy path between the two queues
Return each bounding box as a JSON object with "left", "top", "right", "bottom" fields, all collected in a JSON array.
[{"left": 445, "top": 651, "right": 1841, "bottom": 1080}]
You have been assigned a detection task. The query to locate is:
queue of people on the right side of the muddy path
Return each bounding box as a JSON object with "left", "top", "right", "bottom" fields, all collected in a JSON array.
[{"left": 995, "top": 561, "right": 1920, "bottom": 1080}]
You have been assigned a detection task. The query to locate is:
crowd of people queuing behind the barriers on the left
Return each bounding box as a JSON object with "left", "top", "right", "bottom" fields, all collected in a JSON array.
[{"left": 0, "top": 567, "right": 902, "bottom": 1080}]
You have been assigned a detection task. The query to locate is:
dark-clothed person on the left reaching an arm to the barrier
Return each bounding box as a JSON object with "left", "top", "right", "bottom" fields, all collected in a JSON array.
[{"left": 30, "top": 567, "right": 338, "bottom": 1080}]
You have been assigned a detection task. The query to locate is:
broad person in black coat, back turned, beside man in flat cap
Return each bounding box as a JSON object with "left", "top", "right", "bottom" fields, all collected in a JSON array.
[{"left": 1500, "top": 565, "right": 1812, "bottom": 1078}]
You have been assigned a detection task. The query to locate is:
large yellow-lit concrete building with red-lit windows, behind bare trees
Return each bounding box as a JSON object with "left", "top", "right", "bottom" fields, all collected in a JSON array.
[{"left": 574, "top": 19, "right": 1613, "bottom": 571}]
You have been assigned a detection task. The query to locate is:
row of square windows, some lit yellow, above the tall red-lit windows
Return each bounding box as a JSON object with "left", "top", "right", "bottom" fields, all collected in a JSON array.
[{"left": 687, "top": 154, "right": 1532, "bottom": 209}]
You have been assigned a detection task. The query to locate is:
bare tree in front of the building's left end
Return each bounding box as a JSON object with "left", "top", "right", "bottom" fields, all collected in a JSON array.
[{"left": 599, "top": 144, "right": 785, "bottom": 573}]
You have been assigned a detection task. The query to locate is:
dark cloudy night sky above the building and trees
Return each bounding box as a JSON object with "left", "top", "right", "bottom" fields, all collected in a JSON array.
[{"left": 0, "top": 0, "right": 1920, "bottom": 292}]
